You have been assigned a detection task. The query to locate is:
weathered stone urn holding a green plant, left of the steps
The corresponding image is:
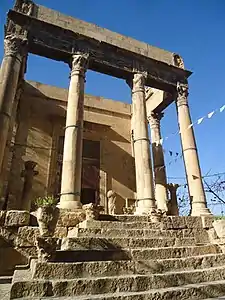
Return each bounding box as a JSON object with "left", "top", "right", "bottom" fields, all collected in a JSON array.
[{"left": 35, "top": 196, "right": 59, "bottom": 237}]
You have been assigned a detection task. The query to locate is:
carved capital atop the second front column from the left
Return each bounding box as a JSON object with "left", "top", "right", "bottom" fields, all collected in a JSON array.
[{"left": 71, "top": 53, "right": 89, "bottom": 76}]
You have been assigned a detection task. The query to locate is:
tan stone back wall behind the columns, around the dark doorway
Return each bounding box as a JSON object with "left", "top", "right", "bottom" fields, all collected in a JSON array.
[{"left": 4, "top": 82, "right": 135, "bottom": 213}]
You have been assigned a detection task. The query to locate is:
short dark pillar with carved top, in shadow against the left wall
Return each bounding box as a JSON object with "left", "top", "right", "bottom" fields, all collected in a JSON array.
[{"left": 21, "top": 160, "right": 38, "bottom": 211}]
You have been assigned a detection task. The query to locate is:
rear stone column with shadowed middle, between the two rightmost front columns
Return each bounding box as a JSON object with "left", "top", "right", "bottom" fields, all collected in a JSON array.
[{"left": 148, "top": 112, "right": 168, "bottom": 211}]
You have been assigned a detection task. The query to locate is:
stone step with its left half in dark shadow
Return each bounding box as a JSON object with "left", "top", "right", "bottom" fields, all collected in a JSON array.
[{"left": 54, "top": 244, "right": 221, "bottom": 262}]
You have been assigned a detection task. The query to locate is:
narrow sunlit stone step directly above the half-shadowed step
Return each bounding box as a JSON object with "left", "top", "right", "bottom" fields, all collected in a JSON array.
[{"left": 68, "top": 228, "right": 209, "bottom": 242}]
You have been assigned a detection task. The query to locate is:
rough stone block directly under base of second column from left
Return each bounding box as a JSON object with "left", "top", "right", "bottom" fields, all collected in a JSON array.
[{"left": 57, "top": 209, "right": 86, "bottom": 227}]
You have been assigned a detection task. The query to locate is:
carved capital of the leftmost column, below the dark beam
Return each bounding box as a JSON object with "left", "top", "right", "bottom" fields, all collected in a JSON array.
[{"left": 4, "top": 34, "right": 27, "bottom": 60}]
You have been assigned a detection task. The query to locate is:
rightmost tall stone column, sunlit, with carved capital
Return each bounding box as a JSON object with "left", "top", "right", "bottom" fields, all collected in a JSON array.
[{"left": 176, "top": 83, "right": 210, "bottom": 216}]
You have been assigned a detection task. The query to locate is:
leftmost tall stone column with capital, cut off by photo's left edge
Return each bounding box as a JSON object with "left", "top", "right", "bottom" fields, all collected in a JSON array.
[{"left": 0, "top": 34, "right": 27, "bottom": 172}]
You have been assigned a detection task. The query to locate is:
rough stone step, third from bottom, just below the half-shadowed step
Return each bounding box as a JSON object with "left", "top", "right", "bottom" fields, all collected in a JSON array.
[{"left": 32, "top": 254, "right": 225, "bottom": 279}]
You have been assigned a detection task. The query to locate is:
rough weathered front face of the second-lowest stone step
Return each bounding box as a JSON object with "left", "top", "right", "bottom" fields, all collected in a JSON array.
[{"left": 13, "top": 267, "right": 225, "bottom": 299}]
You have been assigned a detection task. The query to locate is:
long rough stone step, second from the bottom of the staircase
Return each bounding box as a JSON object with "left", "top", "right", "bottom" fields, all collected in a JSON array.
[{"left": 11, "top": 266, "right": 225, "bottom": 300}]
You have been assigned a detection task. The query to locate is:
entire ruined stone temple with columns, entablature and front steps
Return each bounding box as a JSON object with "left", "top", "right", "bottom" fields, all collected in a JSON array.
[{"left": 0, "top": 0, "right": 225, "bottom": 300}]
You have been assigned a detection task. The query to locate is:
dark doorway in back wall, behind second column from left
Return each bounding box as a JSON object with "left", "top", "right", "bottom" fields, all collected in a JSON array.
[{"left": 54, "top": 136, "right": 100, "bottom": 204}]
